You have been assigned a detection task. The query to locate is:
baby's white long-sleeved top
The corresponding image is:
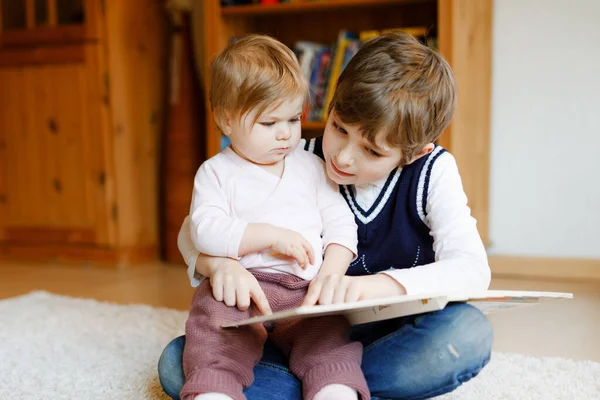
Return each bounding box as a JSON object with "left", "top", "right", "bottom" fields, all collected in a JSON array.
[{"left": 188, "top": 148, "right": 357, "bottom": 280}]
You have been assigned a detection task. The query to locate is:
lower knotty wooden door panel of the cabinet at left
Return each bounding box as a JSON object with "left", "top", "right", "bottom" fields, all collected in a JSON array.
[{"left": 0, "top": 54, "right": 109, "bottom": 244}]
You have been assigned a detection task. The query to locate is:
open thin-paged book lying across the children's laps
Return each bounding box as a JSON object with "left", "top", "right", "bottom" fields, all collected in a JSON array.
[{"left": 223, "top": 290, "right": 573, "bottom": 328}]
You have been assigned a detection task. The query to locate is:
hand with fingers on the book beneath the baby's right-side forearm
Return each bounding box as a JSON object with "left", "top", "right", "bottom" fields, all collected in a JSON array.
[{"left": 301, "top": 273, "right": 361, "bottom": 306}]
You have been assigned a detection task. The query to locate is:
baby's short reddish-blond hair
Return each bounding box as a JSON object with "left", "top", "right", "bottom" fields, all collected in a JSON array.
[{"left": 210, "top": 34, "right": 308, "bottom": 129}]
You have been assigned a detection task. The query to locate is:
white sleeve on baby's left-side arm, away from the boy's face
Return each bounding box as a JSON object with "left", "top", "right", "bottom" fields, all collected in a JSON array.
[{"left": 190, "top": 160, "right": 248, "bottom": 258}]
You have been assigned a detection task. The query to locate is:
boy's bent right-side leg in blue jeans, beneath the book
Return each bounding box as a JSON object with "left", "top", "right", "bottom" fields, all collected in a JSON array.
[{"left": 351, "top": 304, "right": 493, "bottom": 400}]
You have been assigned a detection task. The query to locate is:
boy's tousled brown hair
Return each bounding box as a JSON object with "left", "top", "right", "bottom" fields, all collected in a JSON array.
[{"left": 329, "top": 33, "right": 456, "bottom": 165}]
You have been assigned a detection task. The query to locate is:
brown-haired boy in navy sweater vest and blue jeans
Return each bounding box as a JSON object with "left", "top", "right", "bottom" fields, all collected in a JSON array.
[{"left": 159, "top": 33, "right": 493, "bottom": 399}]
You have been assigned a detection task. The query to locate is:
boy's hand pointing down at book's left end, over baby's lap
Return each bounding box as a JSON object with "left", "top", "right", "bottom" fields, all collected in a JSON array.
[{"left": 210, "top": 258, "right": 273, "bottom": 315}]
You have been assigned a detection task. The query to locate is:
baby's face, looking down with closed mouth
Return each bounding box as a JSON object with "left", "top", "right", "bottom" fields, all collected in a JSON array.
[{"left": 223, "top": 96, "right": 304, "bottom": 165}]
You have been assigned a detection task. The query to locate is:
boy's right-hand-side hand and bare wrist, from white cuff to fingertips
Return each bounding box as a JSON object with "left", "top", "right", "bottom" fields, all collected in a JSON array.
[{"left": 301, "top": 274, "right": 406, "bottom": 306}]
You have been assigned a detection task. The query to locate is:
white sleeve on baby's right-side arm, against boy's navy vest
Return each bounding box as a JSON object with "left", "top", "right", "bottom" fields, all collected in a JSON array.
[{"left": 314, "top": 156, "right": 358, "bottom": 257}]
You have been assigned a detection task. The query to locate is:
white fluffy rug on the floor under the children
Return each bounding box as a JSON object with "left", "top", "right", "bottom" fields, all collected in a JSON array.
[{"left": 0, "top": 292, "right": 600, "bottom": 400}]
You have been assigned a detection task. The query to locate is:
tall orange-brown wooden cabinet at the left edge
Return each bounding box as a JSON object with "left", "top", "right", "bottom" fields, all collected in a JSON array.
[{"left": 0, "top": 0, "right": 167, "bottom": 264}]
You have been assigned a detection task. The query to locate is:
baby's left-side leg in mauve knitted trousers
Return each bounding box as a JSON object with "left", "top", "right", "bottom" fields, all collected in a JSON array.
[{"left": 181, "top": 280, "right": 267, "bottom": 400}]
